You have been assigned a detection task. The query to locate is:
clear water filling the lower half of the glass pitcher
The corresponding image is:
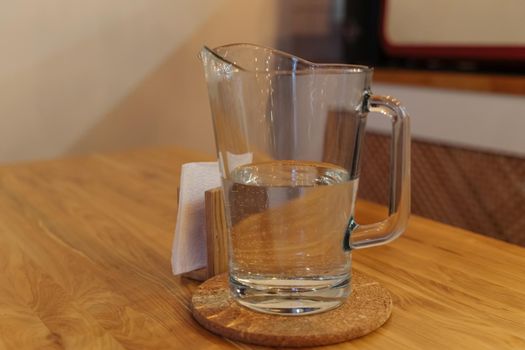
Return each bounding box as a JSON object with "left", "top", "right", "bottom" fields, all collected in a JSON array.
[{"left": 224, "top": 161, "right": 357, "bottom": 314}]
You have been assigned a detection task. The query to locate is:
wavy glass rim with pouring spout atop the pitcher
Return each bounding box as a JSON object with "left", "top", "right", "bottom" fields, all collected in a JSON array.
[{"left": 203, "top": 43, "right": 374, "bottom": 74}]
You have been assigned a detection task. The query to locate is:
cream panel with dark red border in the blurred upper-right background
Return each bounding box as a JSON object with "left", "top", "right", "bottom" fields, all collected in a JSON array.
[{"left": 381, "top": 0, "right": 525, "bottom": 62}]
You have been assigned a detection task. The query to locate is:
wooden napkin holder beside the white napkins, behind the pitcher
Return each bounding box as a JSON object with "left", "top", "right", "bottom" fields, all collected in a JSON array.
[{"left": 183, "top": 187, "right": 228, "bottom": 281}]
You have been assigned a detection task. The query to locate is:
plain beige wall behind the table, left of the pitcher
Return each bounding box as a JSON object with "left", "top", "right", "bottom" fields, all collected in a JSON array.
[{"left": 0, "top": 0, "right": 277, "bottom": 162}]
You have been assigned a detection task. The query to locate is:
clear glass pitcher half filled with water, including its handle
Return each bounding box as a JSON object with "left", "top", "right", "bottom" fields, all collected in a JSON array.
[{"left": 200, "top": 44, "right": 410, "bottom": 315}]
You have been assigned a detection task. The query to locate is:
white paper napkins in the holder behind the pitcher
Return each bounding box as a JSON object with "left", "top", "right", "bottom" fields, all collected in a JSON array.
[{"left": 171, "top": 162, "right": 221, "bottom": 275}]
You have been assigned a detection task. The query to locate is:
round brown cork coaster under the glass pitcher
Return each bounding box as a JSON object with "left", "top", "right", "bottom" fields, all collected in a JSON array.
[{"left": 191, "top": 272, "right": 393, "bottom": 347}]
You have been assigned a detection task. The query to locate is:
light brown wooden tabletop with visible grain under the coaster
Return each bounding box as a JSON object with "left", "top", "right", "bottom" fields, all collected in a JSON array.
[{"left": 0, "top": 149, "right": 525, "bottom": 349}]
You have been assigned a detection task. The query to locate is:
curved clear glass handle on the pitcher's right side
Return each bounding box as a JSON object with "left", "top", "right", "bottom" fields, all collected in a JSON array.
[{"left": 347, "top": 95, "right": 410, "bottom": 249}]
